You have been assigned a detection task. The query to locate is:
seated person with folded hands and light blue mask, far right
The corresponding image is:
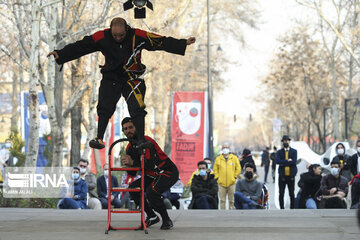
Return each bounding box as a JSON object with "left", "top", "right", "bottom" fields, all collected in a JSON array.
[{"left": 320, "top": 160, "right": 349, "bottom": 208}]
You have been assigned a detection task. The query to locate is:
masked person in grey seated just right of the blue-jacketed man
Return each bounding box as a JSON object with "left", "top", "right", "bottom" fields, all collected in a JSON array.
[{"left": 78, "top": 158, "right": 102, "bottom": 210}]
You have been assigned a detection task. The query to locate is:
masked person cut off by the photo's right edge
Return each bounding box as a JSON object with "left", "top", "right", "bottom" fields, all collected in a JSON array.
[{"left": 349, "top": 139, "right": 360, "bottom": 209}]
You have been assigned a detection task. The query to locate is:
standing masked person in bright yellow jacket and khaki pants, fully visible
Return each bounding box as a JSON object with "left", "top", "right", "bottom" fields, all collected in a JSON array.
[{"left": 213, "top": 145, "right": 241, "bottom": 210}]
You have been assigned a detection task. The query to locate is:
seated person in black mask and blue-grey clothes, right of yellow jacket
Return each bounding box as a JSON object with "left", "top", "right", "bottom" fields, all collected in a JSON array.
[{"left": 234, "top": 163, "right": 264, "bottom": 209}]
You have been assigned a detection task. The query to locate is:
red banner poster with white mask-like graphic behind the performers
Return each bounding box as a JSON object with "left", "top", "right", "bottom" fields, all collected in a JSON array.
[{"left": 171, "top": 92, "right": 207, "bottom": 184}]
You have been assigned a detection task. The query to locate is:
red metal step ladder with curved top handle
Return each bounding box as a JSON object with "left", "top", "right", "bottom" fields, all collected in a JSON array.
[{"left": 105, "top": 138, "right": 148, "bottom": 234}]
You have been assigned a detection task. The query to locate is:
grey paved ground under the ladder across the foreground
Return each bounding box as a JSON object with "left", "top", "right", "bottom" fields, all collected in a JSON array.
[{"left": 0, "top": 208, "right": 360, "bottom": 240}]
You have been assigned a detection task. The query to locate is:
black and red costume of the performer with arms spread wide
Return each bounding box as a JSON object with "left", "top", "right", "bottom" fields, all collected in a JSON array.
[{"left": 55, "top": 25, "right": 186, "bottom": 142}]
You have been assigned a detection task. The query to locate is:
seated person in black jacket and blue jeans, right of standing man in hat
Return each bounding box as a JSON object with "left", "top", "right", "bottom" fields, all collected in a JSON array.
[{"left": 299, "top": 164, "right": 321, "bottom": 209}]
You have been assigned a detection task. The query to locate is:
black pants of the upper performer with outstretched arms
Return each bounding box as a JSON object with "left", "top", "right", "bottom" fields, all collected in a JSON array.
[{"left": 97, "top": 73, "right": 146, "bottom": 140}]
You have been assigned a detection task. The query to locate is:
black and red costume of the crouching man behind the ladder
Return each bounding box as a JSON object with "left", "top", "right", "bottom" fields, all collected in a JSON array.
[{"left": 126, "top": 136, "right": 179, "bottom": 220}]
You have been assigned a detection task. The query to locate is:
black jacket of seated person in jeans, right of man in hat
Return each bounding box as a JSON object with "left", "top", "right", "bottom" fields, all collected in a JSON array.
[{"left": 299, "top": 172, "right": 321, "bottom": 208}]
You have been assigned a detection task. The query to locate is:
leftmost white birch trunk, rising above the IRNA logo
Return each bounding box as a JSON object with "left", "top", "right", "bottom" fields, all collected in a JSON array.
[{"left": 25, "top": 0, "right": 41, "bottom": 167}]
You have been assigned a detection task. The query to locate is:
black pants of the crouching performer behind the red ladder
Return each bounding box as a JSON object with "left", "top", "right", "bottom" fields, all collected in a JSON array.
[{"left": 129, "top": 167, "right": 179, "bottom": 220}]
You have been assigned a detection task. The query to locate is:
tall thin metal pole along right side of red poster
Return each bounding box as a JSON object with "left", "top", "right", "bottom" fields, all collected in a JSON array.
[{"left": 206, "top": 0, "right": 214, "bottom": 161}]
